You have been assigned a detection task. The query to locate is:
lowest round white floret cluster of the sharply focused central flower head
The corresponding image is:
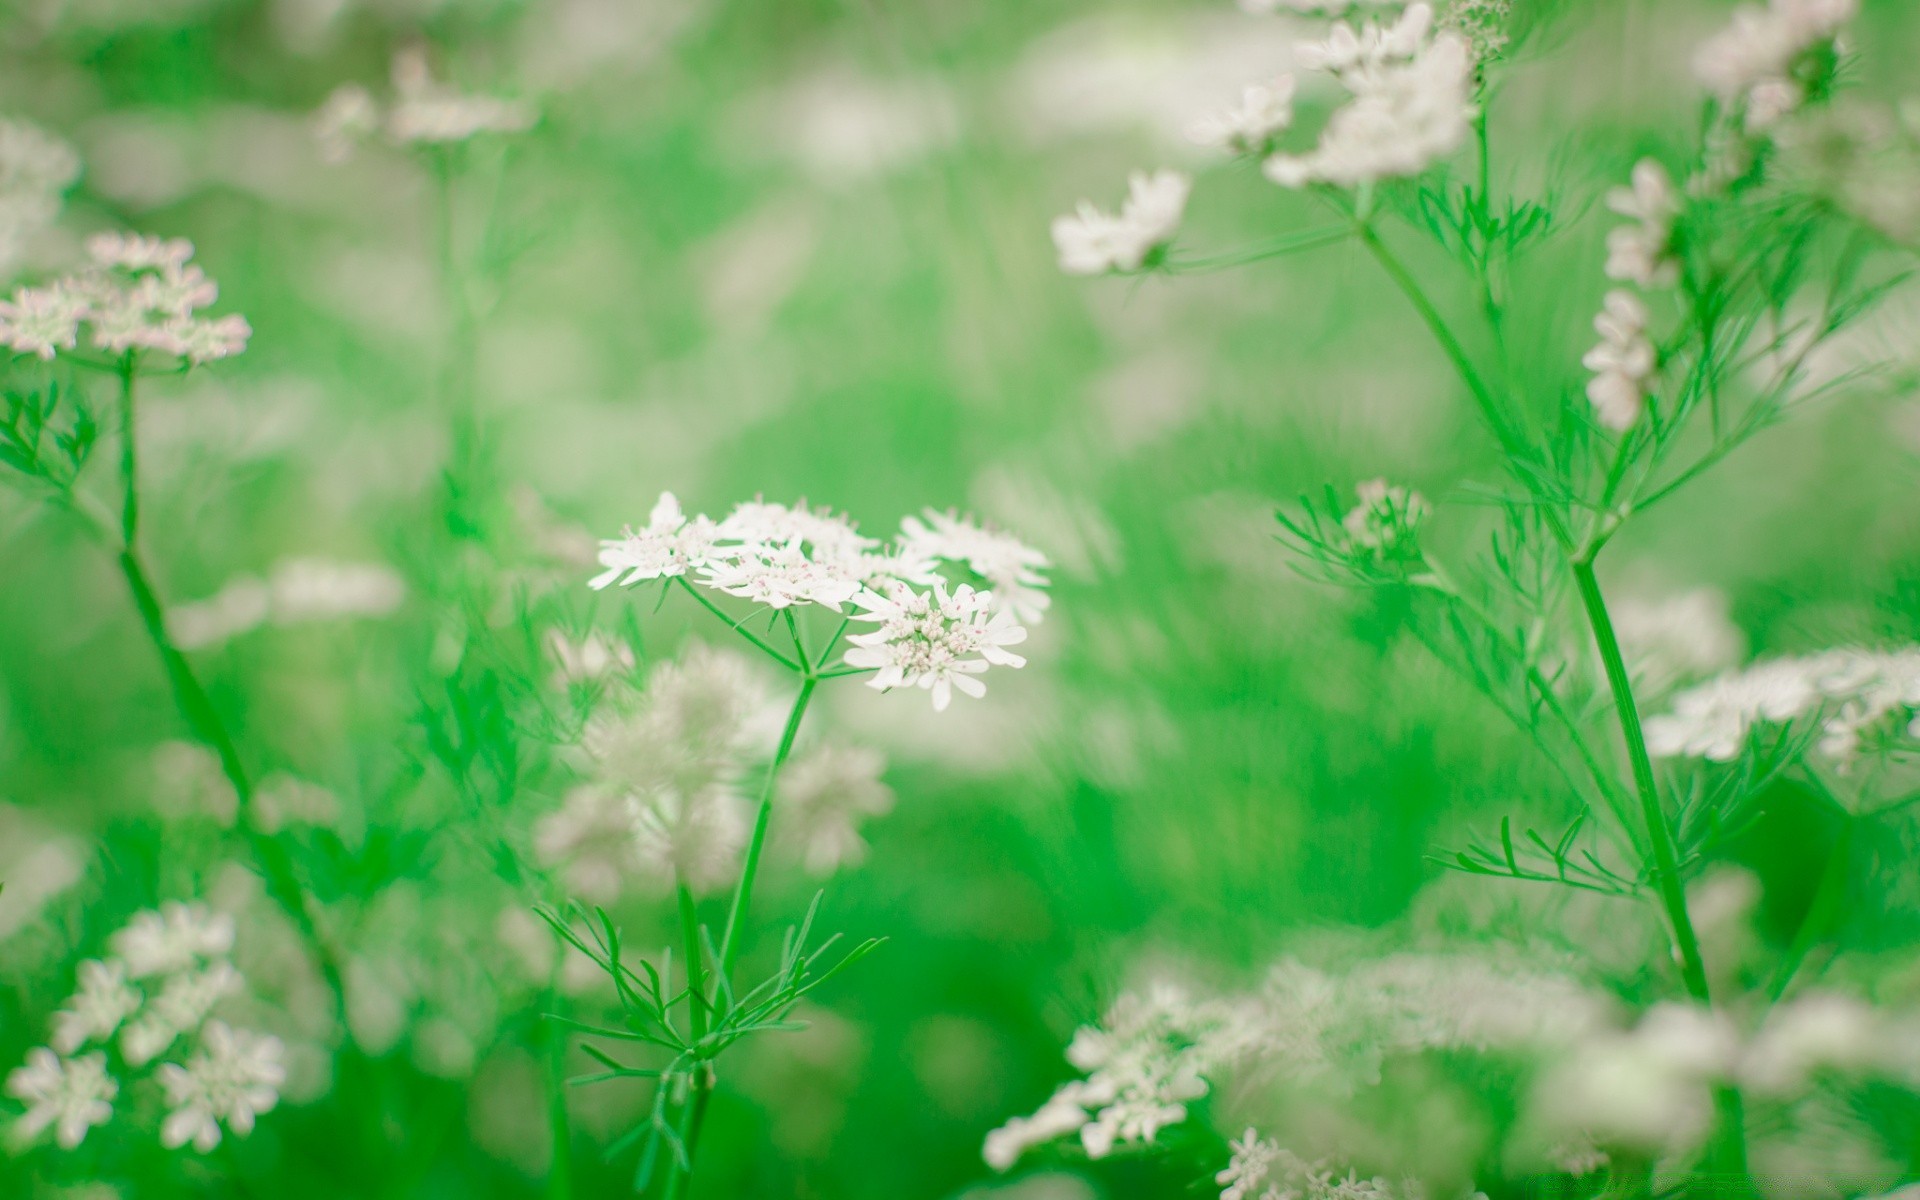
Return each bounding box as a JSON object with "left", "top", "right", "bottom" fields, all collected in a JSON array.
[{"left": 847, "top": 584, "right": 1027, "bottom": 712}]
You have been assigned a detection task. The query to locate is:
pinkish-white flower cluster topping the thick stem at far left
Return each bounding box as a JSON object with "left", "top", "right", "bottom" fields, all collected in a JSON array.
[{"left": 0, "top": 234, "right": 253, "bottom": 363}]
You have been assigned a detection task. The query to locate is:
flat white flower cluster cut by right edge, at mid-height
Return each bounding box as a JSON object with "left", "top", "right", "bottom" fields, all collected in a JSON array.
[{"left": 1647, "top": 647, "right": 1920, "bottom": 766}]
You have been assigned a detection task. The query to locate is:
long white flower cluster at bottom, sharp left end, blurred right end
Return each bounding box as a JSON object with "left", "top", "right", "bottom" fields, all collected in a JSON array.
[{"left": 985, "top": 954, "right": 1607, "bottom": 1169}]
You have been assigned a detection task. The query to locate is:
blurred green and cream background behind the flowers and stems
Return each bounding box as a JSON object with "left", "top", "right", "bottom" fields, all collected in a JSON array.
[{"left": 11, "top": 0, "right": 1920, "bottom": 1200}]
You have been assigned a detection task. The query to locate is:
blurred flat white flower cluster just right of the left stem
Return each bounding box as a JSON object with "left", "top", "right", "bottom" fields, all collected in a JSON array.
[{"left": 167, "top": 559, "right": 407, "bottom": 651}]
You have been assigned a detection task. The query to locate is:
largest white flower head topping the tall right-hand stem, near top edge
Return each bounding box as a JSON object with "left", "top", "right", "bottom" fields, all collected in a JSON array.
[{"left": 1265, "top": 4, "right": 1475, "bottom": 188}]
